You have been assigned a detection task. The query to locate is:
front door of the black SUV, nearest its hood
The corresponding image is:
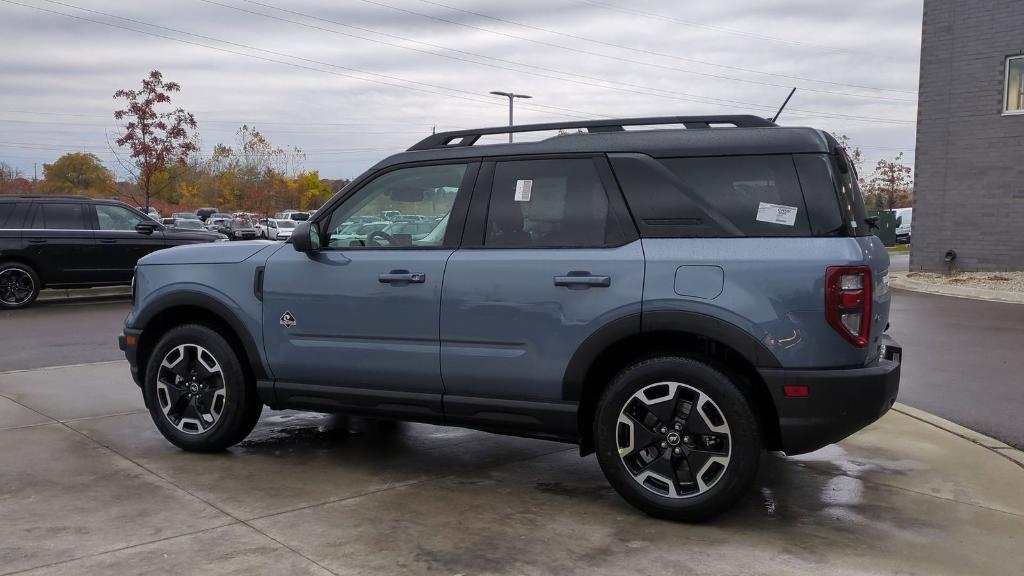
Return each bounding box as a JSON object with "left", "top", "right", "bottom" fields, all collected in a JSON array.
[{"left": 90, "top": 204, "right": 167, "bottom": 284}]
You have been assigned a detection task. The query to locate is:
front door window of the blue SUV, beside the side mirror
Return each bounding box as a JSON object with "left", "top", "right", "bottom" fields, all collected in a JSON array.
[{"left": 324, "top": 164, "right": 466, "bottom": 248}]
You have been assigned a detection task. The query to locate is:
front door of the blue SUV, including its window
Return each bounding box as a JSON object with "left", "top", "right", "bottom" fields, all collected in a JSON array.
[{"left": 263, "top": 158, "right": 476, "bottom": 420}]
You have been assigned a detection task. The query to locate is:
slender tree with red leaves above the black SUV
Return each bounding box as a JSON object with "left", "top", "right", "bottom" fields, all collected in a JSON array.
[{"left": 114, "top": 70, "right": 199, "bottom": 209}]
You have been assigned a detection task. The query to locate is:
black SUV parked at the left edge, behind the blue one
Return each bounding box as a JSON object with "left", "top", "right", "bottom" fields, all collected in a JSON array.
[{"left": 0, "top": 195, "right": 226, "bottom": 308}]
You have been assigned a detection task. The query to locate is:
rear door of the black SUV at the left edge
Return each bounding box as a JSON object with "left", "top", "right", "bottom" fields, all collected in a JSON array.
[{"left": 23, "top": 201, "right": 96, "bottom": 285}]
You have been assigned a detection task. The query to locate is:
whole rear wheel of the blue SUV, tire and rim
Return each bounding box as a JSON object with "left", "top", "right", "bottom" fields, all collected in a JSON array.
[{"left": 594, "top": 357, "right": 762, "bottom": 522}]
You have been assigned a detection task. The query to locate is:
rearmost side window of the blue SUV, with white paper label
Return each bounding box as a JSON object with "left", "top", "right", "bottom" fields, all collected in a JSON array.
[{"left": 612, "top": 156, "right": 810, "bottom": 238}]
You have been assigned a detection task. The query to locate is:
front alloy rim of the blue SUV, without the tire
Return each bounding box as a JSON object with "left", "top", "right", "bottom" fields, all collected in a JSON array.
[{"left": 157, "top": 344, "right": 227, "bottom": 435}]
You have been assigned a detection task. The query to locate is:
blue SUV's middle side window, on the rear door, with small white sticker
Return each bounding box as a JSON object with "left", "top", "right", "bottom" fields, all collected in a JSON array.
[{"left": 483, "top": 159, "right": 622, "bottom": 248}]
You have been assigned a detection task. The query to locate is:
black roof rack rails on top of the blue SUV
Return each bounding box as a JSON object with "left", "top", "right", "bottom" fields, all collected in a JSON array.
[{"left": 409, "top": 114, "right": 776, "bottom": 151}]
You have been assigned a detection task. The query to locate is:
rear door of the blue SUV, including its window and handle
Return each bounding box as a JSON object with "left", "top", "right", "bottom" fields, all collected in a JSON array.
[{"left": 440, "top": 156, "right": 644, "bottom": 435}]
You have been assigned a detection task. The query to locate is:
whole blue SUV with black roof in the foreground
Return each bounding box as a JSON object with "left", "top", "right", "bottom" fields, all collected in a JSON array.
[{"left": 120, "top": 116, "right": 901, "bottom": 520}]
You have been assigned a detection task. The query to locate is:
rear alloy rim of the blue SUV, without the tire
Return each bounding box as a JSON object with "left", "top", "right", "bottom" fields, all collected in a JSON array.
[{"left": 615, "top": 382, "right": 732, "bottom": 498}]
